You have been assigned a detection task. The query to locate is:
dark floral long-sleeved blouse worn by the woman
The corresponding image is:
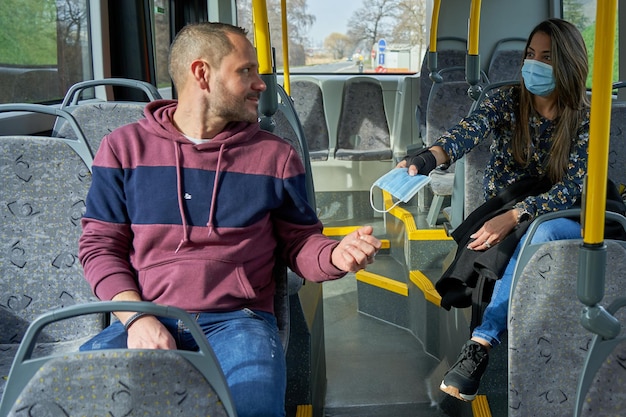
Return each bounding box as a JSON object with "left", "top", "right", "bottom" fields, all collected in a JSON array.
[{"left": 434, "top": 86, "right": 589, "bottom": 218}]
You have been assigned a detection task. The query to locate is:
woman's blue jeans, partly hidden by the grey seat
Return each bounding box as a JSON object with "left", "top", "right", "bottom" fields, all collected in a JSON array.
[{"left": 472, "top": 218, "right": 581, "bottom": 346}]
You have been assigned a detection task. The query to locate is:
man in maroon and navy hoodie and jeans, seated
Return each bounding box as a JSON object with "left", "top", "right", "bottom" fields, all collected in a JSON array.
[{"left": 79, "top": 23, "right": 380, "bottom": 417}]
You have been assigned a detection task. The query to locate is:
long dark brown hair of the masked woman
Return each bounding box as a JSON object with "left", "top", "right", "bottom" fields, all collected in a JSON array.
[{"left": 512, "top": 19, "right": 589, "bottom": 183}]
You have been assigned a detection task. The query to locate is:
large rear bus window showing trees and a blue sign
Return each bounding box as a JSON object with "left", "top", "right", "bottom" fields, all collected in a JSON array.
[{"left": 237, "top": 0, "right": 427, "bottom": 74}]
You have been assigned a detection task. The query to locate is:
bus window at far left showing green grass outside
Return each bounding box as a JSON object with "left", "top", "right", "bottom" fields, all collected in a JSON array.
[{"left": 0, "top": 0, "right": 93, "bottom": 103}]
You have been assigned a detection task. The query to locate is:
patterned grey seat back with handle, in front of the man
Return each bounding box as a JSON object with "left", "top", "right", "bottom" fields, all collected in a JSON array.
[{"left": 0, "top": 302, "right": 236, "bottom": 417}]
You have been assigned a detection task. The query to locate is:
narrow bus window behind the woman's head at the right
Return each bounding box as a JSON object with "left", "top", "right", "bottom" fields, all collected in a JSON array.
[{"left": 563, "top": 0, "right": 619, "bottom": 88}]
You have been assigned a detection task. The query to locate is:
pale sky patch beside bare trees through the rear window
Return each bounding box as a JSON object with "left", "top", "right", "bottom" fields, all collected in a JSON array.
[{"left": 307, "top": 0, "right": 363, "bottom": 45}]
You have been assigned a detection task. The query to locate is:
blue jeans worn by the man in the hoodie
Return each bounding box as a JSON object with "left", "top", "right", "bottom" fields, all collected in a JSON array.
[{"left": 80, "top": 309, "right": 287, "bottom": 417}]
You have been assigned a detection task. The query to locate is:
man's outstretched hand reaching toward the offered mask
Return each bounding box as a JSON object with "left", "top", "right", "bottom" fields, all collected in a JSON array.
[{"left": 331, "top": 226, "right": 381, "bottom": 272}]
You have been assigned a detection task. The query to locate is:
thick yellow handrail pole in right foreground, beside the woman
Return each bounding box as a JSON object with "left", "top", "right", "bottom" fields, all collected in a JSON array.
[{"left": 583, "top": 0, "right": 617, "bottom": 244}]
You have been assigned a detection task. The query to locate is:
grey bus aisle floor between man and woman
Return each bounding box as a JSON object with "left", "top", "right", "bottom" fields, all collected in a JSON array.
[{"left": 324, "top": 274, "right": 446, "bottom": 417}]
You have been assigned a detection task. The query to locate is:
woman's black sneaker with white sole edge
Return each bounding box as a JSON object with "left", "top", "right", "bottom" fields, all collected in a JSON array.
[{"left": 439, "top": 340, "right": 489, "bottom": 401}]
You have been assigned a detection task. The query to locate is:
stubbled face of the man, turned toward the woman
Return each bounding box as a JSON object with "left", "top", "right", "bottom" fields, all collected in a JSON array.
[{"left": 209, "top": 34, "right": 265, "bottom": 123}]
